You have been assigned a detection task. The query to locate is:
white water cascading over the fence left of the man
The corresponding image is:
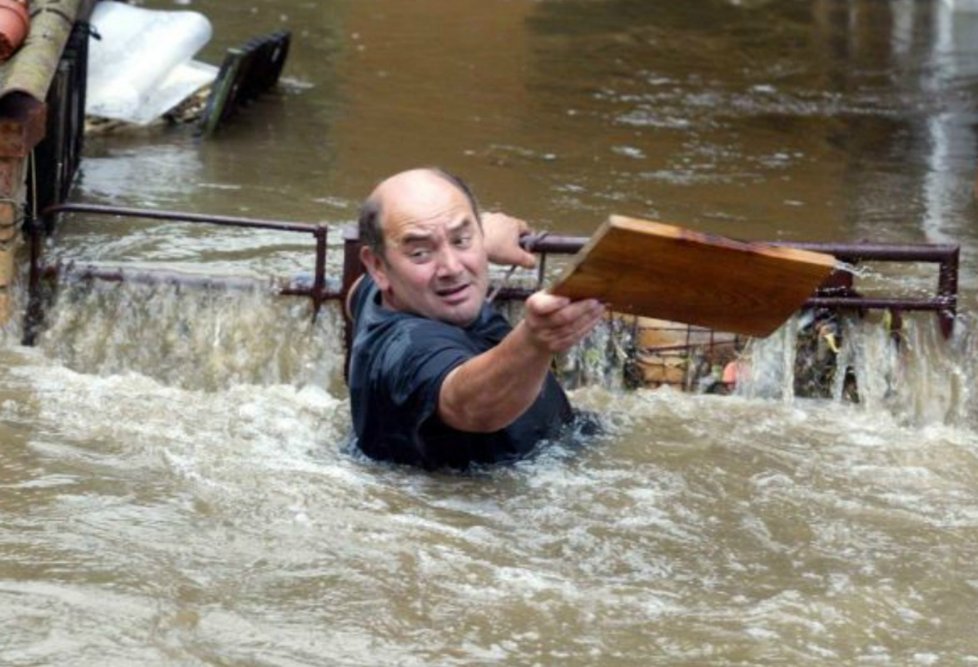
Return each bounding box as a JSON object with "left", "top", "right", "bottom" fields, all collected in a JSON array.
[{"left": 21, "top": 283, "right": 344, "bottom": 391}]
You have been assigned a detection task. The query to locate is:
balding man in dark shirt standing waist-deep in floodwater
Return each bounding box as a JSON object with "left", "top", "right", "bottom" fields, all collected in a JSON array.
[{"left": 348, "top": 169, "right": 604, "bottom": 470}]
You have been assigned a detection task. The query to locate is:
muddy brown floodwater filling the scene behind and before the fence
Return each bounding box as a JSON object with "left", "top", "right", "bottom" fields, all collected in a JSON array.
[{"left": 0, "top": 0, "right": 978, "bottom": 665}]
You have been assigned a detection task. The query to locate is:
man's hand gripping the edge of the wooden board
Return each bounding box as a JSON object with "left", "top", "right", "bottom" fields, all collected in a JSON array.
[{"left": 523, "top": 291, "right": 605, "bottom": 354}]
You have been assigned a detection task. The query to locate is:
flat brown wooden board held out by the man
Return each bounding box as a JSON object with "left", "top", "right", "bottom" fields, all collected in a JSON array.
[{"left": 550, "top": 215, "right": 835, "bottom": 337}]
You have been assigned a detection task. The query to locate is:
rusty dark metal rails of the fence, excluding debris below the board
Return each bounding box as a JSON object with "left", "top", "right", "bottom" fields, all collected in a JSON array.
[{"left": 24, "top": 203, "right": 960, "bottom": 345}]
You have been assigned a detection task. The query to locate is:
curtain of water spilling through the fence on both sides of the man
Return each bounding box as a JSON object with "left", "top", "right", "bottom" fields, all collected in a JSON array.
[{"left": 7, "top": 272, "right": 978, "bottom": 434}]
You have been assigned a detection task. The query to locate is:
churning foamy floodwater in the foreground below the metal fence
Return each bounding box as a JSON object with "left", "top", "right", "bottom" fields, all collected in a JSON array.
[{"left": 0, "top": 280, "right": 978, "bottom": 664}]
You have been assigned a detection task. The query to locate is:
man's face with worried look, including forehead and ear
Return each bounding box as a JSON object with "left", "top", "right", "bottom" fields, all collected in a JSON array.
[{"left": 364, "top": 176, "right": 489, "bottom": 326}]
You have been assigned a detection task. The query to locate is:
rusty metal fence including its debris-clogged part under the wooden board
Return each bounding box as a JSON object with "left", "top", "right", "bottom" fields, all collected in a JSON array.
[{"left": 24, "top": 203, "right": 959, "bottom": 389}]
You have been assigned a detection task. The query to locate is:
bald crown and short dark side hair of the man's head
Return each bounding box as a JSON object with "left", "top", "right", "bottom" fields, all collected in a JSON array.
[{"left": 358, "top": 167, "right": 481, "bottom": 257}]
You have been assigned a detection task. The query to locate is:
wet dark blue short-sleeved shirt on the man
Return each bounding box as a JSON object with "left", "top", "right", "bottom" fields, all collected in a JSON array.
[{"left": 349, "top": 275, "right": 573, "bottom": 470}]
